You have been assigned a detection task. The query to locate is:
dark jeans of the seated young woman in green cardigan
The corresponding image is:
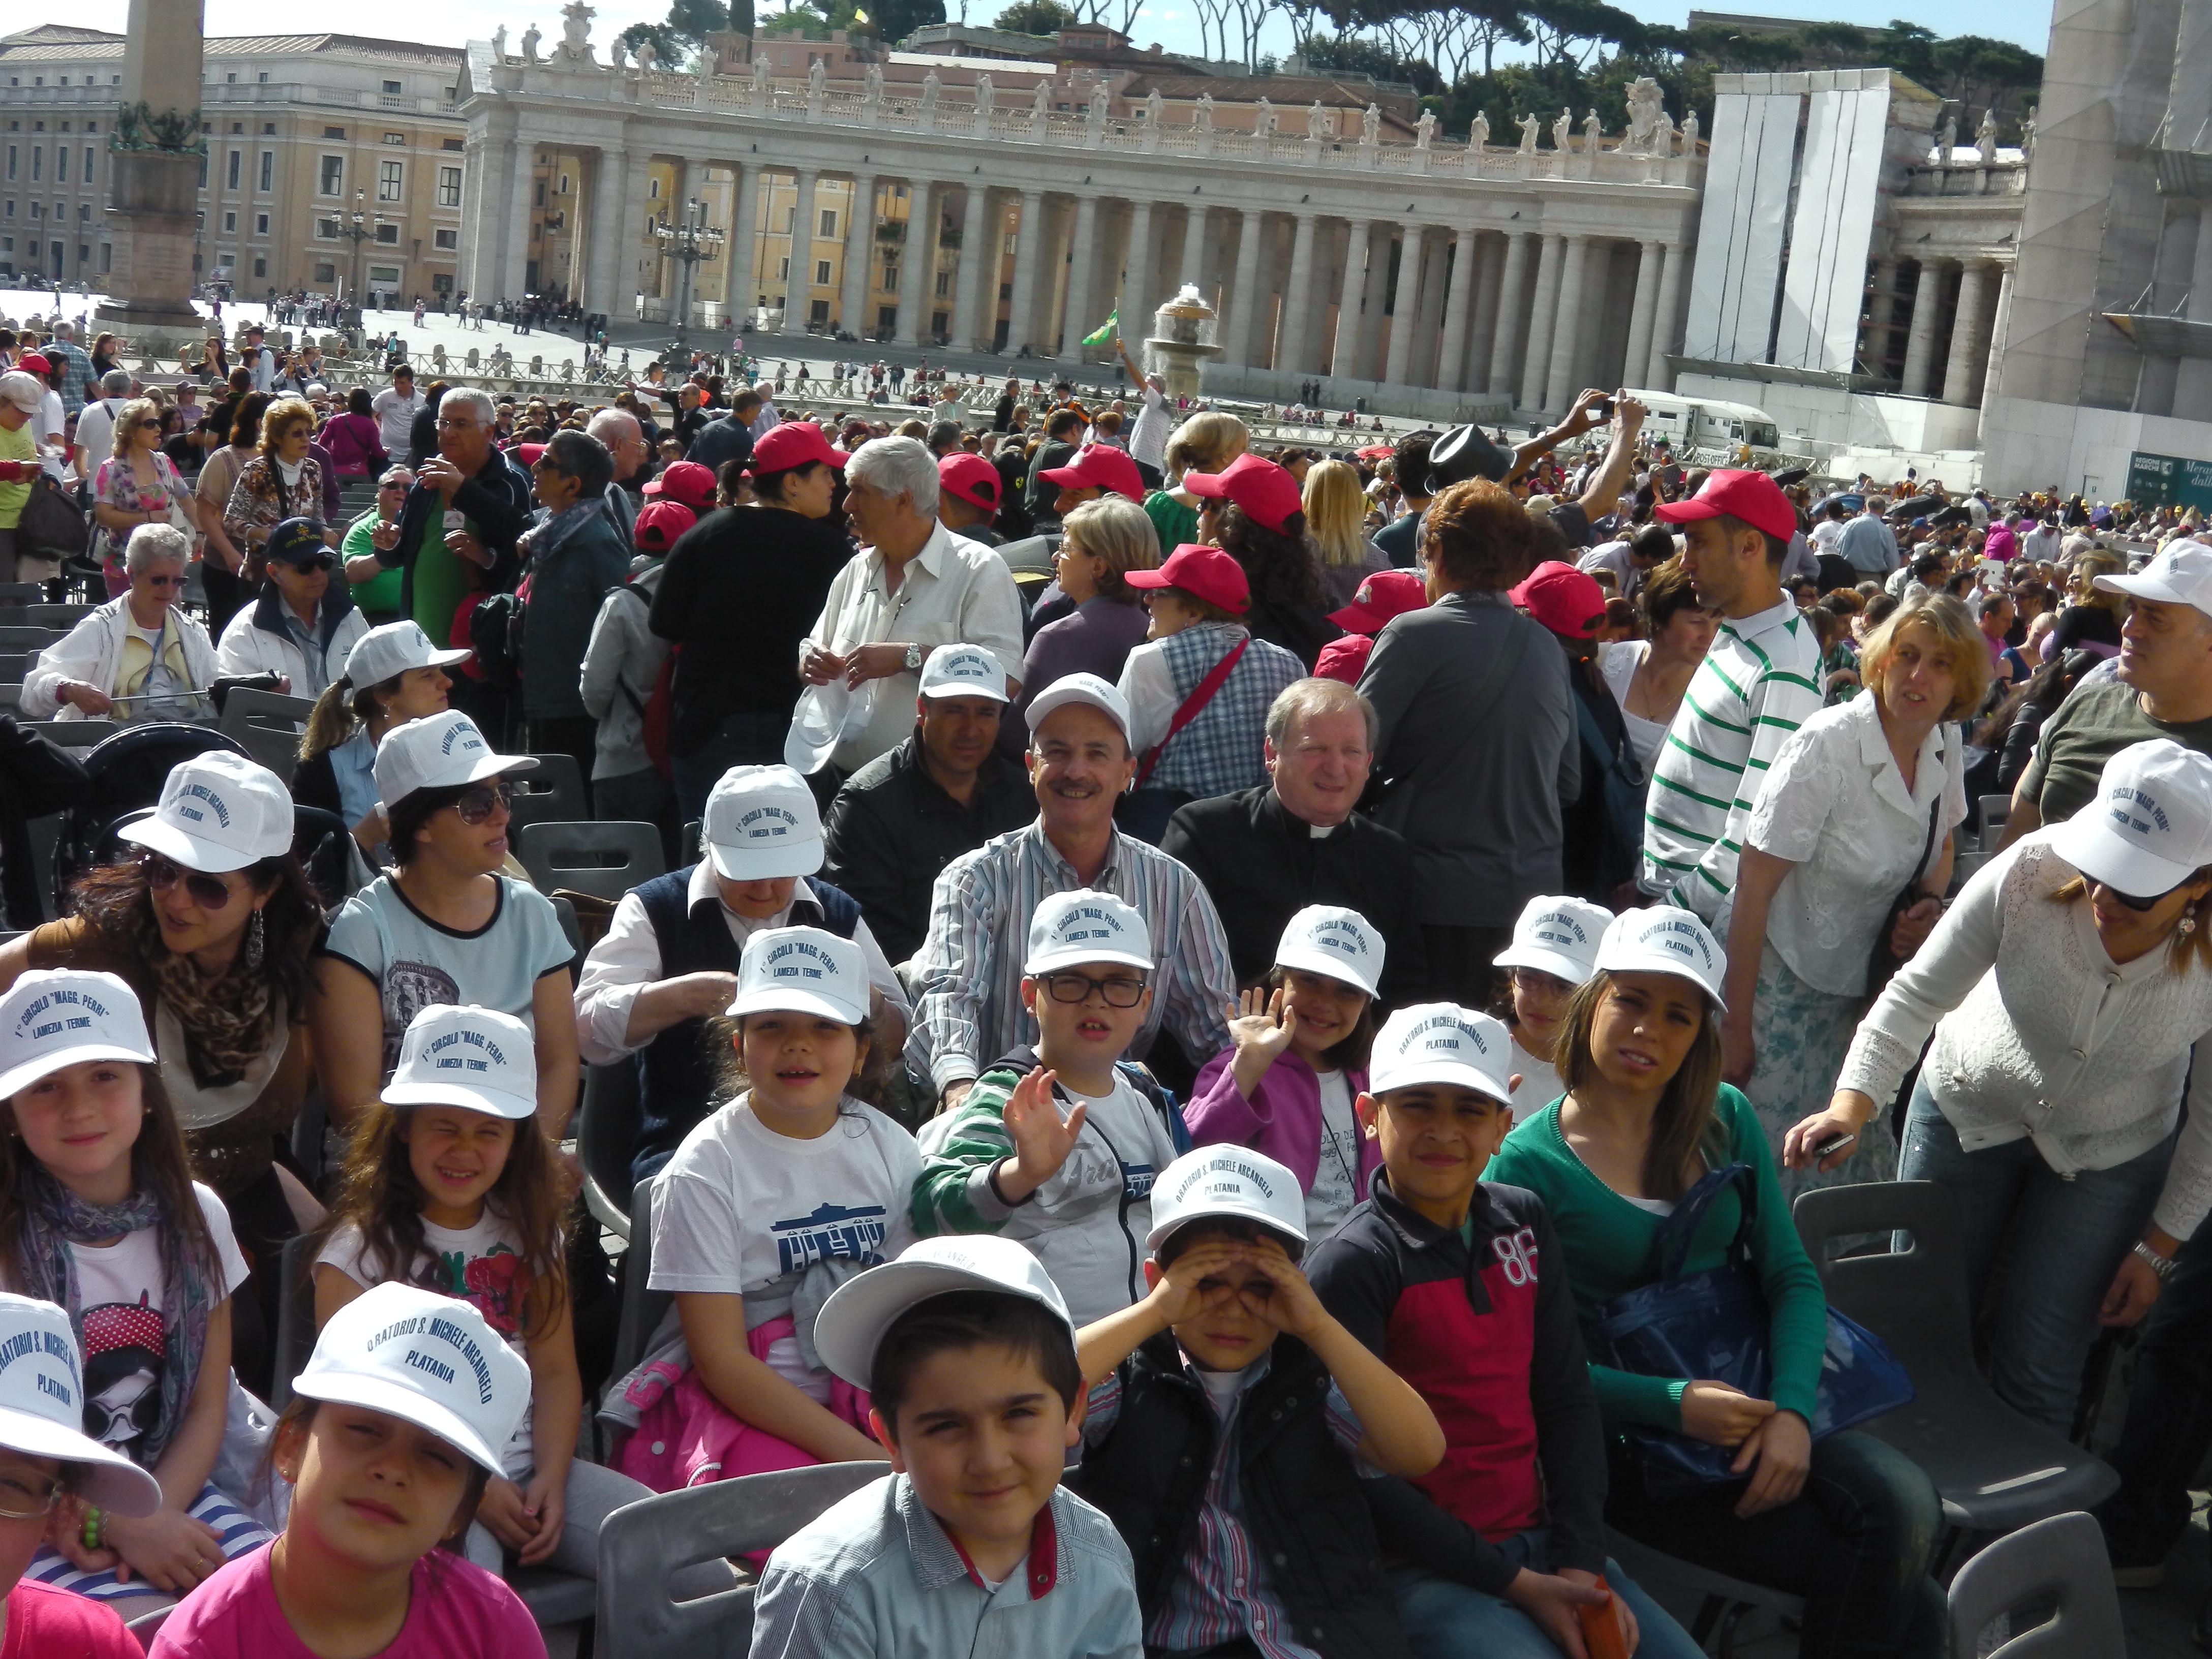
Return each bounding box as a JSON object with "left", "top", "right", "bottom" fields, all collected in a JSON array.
[{"left": 1606, "top": 1429, "right": 1944, "bottom": 1659}]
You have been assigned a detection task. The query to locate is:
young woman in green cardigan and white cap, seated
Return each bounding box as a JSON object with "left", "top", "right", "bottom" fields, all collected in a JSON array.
[{"left": 1489, "top": 907, "right": 1944, "bottom": 1659}]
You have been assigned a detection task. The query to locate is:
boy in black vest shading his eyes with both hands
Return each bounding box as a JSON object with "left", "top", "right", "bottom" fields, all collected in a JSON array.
[{"left": 1073, "top": 1159, "right": 1445, "bottom": 1659}]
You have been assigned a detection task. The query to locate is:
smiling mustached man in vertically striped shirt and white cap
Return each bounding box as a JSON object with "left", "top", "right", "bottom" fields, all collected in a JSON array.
[{"left": 907, "top": 674, "right": 1237, "bottom": 1111}]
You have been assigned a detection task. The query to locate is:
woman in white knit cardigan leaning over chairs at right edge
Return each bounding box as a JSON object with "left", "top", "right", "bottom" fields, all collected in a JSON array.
[{"left": 1783, "top": 739, "right": 2212, "bottom": 1433}]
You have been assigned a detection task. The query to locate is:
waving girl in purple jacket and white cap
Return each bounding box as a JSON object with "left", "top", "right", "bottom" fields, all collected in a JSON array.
[{"left": 1183, "top": 905, "right": 1385, "bottom": 1239}]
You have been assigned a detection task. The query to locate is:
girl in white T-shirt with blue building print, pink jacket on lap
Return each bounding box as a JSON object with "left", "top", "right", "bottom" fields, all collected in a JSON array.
[{"left": 602, "top": 927, "right": 920, "bottom": 1491}]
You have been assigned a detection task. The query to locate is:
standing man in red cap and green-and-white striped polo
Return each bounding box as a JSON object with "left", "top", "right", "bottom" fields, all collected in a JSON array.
[{"left": 1637, "top": 469, "right": 1821, "bottom": 923}]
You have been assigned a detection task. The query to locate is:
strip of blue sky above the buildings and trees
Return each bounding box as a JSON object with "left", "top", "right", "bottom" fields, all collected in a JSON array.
[{"left": 56, "top": 0, "right": 2050, "bottom": 71}]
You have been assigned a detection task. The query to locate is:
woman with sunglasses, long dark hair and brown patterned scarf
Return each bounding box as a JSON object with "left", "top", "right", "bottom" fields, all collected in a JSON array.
[{"left": 0, "top": 750, "right": 323, "bottom": 1398}]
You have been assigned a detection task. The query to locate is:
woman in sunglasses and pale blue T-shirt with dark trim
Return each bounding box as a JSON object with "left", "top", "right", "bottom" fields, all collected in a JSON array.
[{"left": 308, "top": 712, "right": 577, "bottom": 1139}]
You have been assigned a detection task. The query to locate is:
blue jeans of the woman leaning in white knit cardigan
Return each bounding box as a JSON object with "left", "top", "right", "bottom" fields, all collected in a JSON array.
[{"left": 1898, "top": 1080, "right": 2174, "bottom": 1433}]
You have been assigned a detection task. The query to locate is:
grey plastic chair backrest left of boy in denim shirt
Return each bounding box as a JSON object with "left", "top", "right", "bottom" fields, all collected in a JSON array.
[{"left": 595, "top": 1462, "right": 892, "bottom": 1659}]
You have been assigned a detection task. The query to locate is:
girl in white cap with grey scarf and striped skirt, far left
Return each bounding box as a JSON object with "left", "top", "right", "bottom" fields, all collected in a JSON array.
[{"left": 0, "top": 969, "right": 268, "bottom": 1619}]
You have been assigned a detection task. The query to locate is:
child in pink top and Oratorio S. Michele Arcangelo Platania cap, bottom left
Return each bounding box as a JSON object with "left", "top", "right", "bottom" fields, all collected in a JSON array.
[{"left": 152, "top": 1283, "right": 546, "bottom": 1659}]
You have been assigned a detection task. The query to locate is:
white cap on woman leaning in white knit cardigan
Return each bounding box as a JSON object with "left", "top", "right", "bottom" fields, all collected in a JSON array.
[{"left": 2050, "top": 739, "right": 2212, "bottom": 898}]
